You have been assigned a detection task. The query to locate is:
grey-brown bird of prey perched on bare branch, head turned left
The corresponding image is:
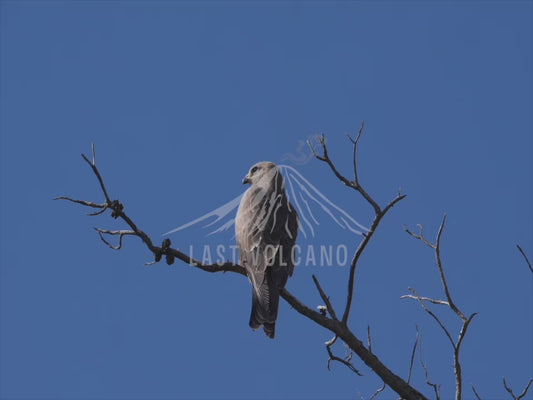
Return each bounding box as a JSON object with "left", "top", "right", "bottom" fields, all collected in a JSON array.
[{"left": 235, "top": 161, "right": 298, "bottom": 338}]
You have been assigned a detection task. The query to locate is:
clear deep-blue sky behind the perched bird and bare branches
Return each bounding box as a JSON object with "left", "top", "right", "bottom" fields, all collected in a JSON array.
[{"left": 0, "top": 0, "right": 533, "bottom": 399}]
